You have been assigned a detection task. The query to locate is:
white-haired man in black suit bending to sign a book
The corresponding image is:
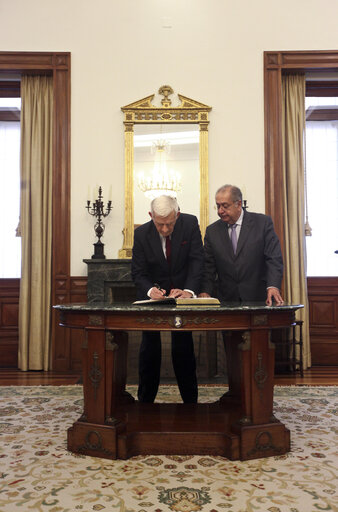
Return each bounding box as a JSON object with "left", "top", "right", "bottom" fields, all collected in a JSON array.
[{"left": 131, "top": 196, "right": 203, "bottom": 403}]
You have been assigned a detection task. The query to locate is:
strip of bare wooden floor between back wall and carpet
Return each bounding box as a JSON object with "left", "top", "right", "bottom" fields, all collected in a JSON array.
[{"left": 0, "top": 366, "right": 338, "bottom": 386}]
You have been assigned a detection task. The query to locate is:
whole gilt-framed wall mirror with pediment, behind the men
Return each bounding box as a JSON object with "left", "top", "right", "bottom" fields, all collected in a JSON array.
[{"left": 119, "top": 86, "right": 211, "bottom": 258}]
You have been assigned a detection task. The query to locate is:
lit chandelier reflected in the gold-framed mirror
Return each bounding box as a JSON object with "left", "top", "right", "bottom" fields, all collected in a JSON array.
[{"left": 137, "top": 139, "right": 182, "bottom": 199}]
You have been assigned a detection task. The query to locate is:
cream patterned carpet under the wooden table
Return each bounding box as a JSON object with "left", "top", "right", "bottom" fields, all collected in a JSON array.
[{"left": 0, "top": 386, "right": 338, "bottom": 512}]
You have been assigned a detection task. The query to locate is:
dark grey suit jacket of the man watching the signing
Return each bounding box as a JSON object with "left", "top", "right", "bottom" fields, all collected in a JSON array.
[{"left": 202, "top": 212, "right": 283, "bottom": 301}]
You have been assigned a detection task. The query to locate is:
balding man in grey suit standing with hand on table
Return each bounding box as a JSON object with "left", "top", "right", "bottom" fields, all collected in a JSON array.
[{"left": 200, "top": 185, "right": 283, "bottom": 306}]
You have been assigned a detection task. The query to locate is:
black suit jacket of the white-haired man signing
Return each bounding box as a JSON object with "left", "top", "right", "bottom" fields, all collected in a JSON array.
[{"left": 131, "top": 213, "right": 203, "bottom": 299}]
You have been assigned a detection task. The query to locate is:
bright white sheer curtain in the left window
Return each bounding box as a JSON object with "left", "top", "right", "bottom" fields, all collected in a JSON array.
[{"left": 0, "top": 121, "right": 21, "bottom": 278}]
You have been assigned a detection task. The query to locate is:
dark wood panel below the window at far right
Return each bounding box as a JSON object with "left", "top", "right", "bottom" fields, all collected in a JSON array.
[{"left": 307, "top": 277, "right": 338, "bottom": 366}]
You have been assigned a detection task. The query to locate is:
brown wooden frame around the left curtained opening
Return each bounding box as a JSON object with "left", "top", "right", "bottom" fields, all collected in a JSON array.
[{"left": 0, "top": 52, "right": 71, "bottom": 370}]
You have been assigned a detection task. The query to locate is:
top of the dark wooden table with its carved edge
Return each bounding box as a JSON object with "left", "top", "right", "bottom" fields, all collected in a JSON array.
[{"left": 54, "top": 302, "right": 303, "bottom": 331}]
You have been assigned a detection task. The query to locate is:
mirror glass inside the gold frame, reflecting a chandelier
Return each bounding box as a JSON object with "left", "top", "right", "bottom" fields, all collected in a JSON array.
[{"left": 133, "top": 123, "right": 200, "bottom": 225}]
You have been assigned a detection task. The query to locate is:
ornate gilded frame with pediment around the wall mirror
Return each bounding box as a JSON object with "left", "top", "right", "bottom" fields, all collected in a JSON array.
[{"left": 119, "top": 85, "right": 211, "bottom": 259}]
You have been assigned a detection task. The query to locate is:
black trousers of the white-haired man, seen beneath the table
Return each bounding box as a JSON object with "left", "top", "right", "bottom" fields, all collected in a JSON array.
[{"left": 138, "top": 331, "right": 198, "bottom": 403}]
